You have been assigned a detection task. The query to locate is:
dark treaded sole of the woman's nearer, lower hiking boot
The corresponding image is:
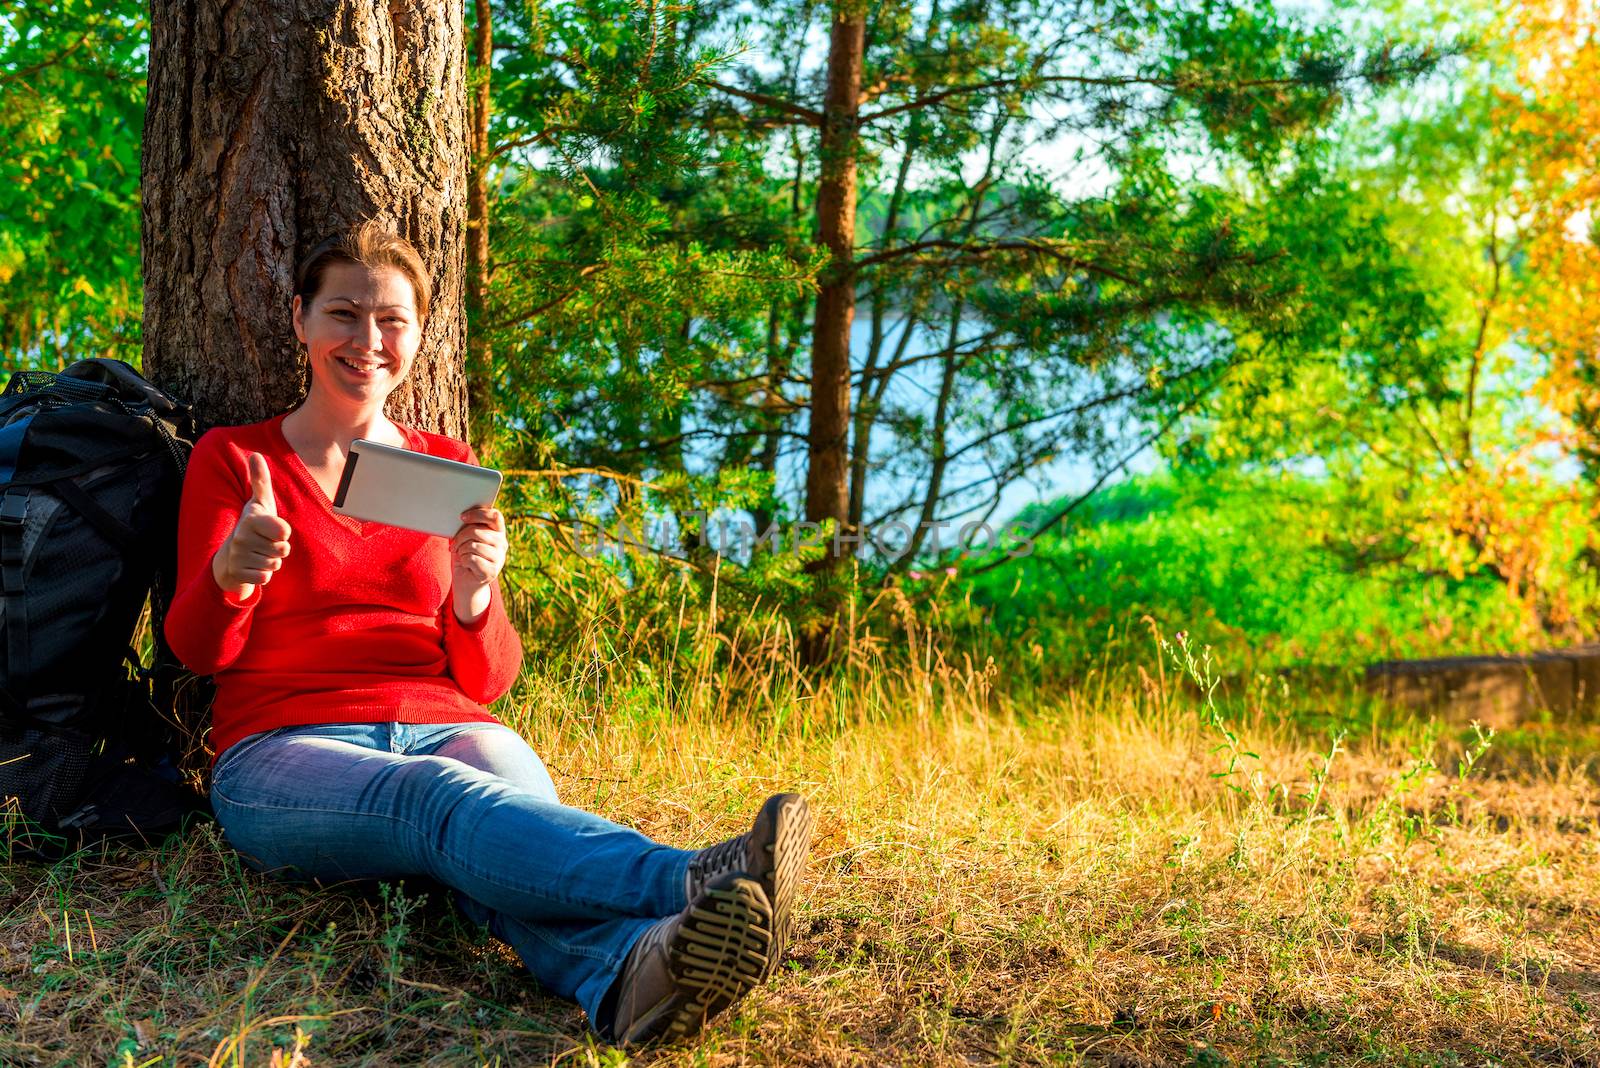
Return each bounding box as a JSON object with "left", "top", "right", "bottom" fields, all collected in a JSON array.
[{"left": 622, "top": 876, "right": 773, "bottom": 1044}]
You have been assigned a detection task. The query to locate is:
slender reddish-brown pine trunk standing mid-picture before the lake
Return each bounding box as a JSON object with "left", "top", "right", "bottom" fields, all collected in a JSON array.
[{"left": 805, "top": 0, "right": 867, "bottom": 569}]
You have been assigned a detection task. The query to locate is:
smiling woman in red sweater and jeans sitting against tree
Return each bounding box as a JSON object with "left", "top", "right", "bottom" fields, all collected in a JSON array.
[{"left": 165, "top": 224, "right": 810, "bottom": 1042}]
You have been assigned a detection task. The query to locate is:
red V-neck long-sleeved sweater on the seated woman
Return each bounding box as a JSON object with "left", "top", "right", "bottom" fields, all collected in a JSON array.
[{"left": 165, "top": 416, "right": 522, "bottom": 761}]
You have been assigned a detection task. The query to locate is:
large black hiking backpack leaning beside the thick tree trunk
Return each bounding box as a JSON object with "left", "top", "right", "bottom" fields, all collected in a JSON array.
[{"left": 0, "top": 358, "right": 208, "bottom": 855}]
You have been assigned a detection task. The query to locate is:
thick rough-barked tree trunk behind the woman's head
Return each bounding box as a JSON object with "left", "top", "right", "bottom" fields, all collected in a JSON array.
[{"left": 141, "top": 0, "right": 467, "bottom": 438}]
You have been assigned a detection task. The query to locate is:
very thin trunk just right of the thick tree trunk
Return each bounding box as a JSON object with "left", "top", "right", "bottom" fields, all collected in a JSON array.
[{"left": 467, "top": 0, "right": 494, "bottom": 456}]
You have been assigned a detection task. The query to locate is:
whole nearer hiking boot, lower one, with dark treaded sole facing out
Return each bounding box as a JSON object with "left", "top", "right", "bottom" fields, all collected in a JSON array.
[{"left": 595, "top": 871, "right": 773, "bottom": 1046}]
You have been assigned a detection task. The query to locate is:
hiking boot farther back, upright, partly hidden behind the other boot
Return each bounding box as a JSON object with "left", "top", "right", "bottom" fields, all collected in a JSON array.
[{"left": 688, "top": 793, "right": 811, "bottom": 980}]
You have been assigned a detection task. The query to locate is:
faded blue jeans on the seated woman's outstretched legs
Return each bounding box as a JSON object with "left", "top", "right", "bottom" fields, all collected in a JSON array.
[{"left": 211, "top": 723, "right": 693, "bottom": 1023}]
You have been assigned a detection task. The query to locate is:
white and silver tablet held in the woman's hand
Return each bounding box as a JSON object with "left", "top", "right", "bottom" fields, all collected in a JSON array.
[{"left": 333, "top": 438, "right": 501, "bottom": 537}]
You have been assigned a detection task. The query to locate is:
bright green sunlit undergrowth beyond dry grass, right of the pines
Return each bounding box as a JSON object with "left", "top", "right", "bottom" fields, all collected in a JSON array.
[{"left": 971, "top": 475, "right": 1592, "bottom": 671}]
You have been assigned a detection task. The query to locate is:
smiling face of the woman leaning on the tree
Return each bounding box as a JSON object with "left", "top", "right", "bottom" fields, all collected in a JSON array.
[{"left": 294, "top": 264, "right": 422, "bottom": 406}]
